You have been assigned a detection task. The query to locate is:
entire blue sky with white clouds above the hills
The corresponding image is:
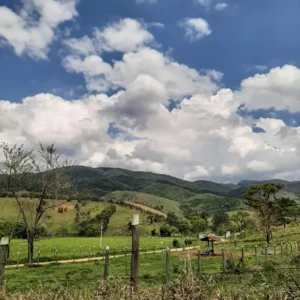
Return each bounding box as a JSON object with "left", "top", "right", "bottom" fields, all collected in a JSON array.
[{"left": 0, "top": 0, "right": 300, "bottom": 183}]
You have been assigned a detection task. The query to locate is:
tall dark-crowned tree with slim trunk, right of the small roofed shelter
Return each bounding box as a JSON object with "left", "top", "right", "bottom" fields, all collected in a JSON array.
[{"left": 243, "top": 183, "right": 283, "bottom": 244}]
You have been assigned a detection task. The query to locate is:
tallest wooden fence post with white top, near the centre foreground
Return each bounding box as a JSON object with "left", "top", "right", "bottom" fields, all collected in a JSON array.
[{"left": 130, "top": 214, "right": 139, "bottom": 292}]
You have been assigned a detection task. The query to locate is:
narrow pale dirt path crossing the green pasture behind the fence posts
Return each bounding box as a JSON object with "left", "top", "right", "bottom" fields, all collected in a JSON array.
[{"left": 5, "top": 247, "right": 197, "bottom": 269}]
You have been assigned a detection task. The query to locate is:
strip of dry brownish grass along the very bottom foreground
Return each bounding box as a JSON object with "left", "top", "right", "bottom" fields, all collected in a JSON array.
[{"left": 0, "top": 275, "right": 300, "bottom": 300}]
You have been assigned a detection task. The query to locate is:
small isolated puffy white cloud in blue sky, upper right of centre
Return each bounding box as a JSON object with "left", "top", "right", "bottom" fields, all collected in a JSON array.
[{"left": 179, "top": 18, "right": 212, "bottom": 42}]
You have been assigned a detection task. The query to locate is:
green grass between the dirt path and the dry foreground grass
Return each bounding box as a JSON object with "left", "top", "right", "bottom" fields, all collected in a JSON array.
[{"left": 5, "top": 245, "right": 298, "bottom": 299}]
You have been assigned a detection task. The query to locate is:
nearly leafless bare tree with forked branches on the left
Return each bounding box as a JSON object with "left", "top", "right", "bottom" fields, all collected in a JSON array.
[{"left": 0, "top": 143, "right": 73, "bottom": 263}]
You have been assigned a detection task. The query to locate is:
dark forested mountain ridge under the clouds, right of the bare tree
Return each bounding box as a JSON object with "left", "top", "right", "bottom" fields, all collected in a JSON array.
[{"left": 71, "top": 166, "right": 300, "bottom": 203}]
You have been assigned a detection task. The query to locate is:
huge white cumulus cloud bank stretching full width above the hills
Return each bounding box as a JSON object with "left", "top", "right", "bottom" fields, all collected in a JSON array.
[{"left": 0, "top": 8, "right": 300, "bottom": 182}]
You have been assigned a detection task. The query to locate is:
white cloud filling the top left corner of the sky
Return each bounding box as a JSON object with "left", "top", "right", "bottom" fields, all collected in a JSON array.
[{"left": 0, "top": 0, "right": 77, "bottom": 59}]
